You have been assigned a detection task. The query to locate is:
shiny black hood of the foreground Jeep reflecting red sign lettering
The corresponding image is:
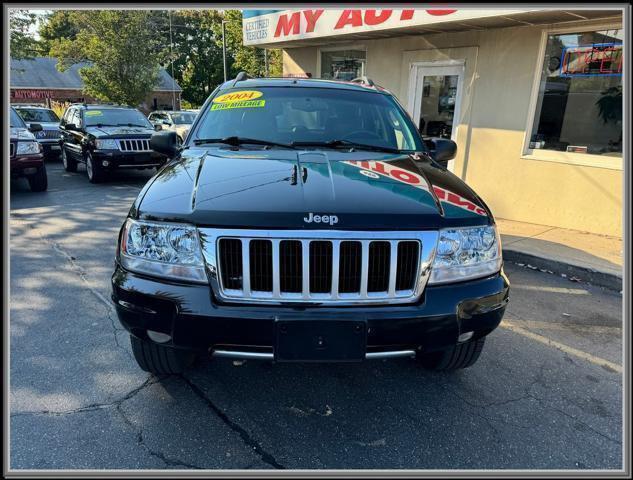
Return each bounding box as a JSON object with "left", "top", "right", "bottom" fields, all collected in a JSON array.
[{"left": 137, "top": 147, "right": 492, "bottom": 230}]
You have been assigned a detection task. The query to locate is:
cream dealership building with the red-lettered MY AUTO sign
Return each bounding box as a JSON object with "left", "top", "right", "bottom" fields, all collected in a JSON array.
[{"left": 244, "top": 8, "right": 624, "bottom": 236}]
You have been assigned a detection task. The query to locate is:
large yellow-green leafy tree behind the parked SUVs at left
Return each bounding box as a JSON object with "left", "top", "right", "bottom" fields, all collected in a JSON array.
[{"left": 50, "top": 10, "right": 164, "bottom": 105}]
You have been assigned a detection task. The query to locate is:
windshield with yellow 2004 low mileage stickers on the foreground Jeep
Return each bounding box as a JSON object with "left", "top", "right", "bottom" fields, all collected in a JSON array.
[{"left": 195, "top": 87, "right": 424, "bottom": 151}]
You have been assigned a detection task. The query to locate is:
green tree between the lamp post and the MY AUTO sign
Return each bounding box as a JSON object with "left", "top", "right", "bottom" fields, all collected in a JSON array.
[{"left": 215, "top": 10, "right": 282, "bottom": 77}]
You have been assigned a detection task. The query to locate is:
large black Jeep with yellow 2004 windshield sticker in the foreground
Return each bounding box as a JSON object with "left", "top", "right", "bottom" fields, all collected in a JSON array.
[{"left": 112, "top": 74, "right": 509, "bottom": 374}]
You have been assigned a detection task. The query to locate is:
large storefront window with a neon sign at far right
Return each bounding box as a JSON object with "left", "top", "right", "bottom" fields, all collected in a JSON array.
[{"left": 529, "top": 30, "right": 624, "bottom": 156}]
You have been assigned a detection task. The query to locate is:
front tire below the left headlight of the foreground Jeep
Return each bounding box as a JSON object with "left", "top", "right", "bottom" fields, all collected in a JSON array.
[{"left": 130, "top": 335, "right": 195, "bottom": 375}]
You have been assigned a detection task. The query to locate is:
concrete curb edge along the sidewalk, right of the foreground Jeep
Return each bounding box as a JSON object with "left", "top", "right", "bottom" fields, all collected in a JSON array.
[{"left": 503, "top": 250, "right": 622, "bottom": 292}]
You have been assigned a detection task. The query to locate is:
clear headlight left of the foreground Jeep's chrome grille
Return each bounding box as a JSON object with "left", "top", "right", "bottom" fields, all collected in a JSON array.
[{"left": 119, "top": 219, "right": 208, "bottom": 283}]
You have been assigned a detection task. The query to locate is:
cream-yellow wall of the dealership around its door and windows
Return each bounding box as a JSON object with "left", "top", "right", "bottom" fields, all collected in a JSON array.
[{"left": 283, "top": 18, "right": 623, "bottom": 237}]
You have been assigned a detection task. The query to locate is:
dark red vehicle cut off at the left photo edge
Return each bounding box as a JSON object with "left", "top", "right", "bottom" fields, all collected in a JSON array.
[{"left": 9, "top": 108, "right": 48, "bottom": 192}]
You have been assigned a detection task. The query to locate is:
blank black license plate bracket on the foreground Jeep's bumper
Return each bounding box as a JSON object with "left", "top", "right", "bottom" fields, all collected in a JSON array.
[{"left": 274, "top": 320, "right": 367, "bottom": 362}]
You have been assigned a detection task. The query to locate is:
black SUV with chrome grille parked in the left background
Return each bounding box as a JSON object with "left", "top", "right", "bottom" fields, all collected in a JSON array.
[{"left": 60, "top": 104, "right": 166, "bottom": 183}]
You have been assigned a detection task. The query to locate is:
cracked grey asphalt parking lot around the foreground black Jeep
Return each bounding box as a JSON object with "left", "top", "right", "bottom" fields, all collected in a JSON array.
[{"left": 10, "top": 162, "right": 622, "bottom": 469}]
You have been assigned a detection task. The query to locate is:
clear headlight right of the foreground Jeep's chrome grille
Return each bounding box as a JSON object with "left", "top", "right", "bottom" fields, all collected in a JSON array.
[{"left": 429, "top": 226, "right": 502, "bottom": 283}]
